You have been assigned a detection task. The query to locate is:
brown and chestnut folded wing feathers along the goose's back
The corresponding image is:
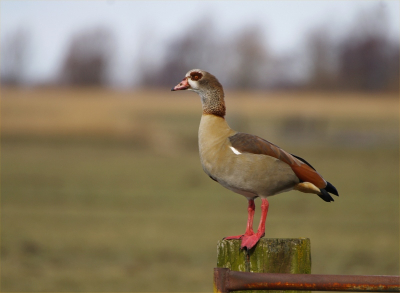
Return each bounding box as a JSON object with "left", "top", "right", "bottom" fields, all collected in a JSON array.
[{"left": 229, "top": 132, "right": 326, "bottom": 188}]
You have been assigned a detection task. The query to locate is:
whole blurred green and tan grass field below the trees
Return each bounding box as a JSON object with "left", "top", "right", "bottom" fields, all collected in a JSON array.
[{"left": 1, "top": 88, "right": 400, "bottom": 292}]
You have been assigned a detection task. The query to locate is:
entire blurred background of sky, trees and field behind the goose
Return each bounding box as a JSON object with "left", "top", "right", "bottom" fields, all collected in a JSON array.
[{"left": 0, "top": 0, "right": 400, "bottom": 292}]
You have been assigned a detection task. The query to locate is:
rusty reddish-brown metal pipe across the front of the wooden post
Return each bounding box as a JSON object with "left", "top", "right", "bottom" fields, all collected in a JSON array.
[{"left": 214, "top": 268, "right": 400, "bottom": 292}]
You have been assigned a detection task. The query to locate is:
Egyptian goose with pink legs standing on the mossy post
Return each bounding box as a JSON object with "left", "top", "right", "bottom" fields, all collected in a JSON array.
[{"left": 171, "top": 69, "right": 339, "bottom": 250}]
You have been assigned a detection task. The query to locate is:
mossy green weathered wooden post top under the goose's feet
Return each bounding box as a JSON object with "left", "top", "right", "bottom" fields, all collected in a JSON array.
[{"left": 217, "top": 238, "right": 311, "bottom": 293}]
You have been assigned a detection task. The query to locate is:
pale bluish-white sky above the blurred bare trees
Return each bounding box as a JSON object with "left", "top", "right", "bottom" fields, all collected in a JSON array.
[{"left": 0, "top": 0, "right": 400, "bottom": 84}]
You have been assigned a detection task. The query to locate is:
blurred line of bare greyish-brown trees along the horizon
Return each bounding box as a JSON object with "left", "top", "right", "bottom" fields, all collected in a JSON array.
[{"left": 1, "top": 9, "right": 399, "bottom": 91}]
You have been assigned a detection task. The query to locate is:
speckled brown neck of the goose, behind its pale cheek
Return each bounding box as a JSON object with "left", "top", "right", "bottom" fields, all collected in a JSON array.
[{"left": 199, "top": 78, "right": 226, "bottom": 117}]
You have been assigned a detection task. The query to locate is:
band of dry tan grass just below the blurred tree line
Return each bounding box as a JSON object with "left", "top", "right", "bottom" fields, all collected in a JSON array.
[{"left": 1, "top": 88, "right": 399, "bottom": 135}]
